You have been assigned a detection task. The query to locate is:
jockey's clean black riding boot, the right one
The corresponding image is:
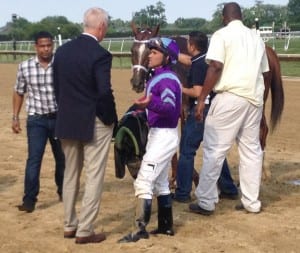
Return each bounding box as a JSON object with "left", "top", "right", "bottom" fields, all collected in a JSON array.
[{"left": 150, "top": 194, "right": 174, "bottom": 236}]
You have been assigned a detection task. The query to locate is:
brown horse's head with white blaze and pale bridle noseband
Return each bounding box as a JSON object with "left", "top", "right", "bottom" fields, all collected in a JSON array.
[{"left": 130, "top": 23, "right": 159, "bottom": 92}]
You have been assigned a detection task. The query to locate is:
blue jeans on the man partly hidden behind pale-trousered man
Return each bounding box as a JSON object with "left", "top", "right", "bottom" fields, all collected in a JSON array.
[{"left": 175, "top": 105, "right": 238, "bottom": 200}]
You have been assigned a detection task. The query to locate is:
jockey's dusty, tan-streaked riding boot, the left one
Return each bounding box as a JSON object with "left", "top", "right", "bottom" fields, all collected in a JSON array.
[{"left": 118, "top": 198, "right": 152, "bottom": 243}]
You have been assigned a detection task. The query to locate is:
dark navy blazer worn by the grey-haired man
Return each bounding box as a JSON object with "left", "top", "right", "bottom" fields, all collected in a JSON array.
[{"left": 53, "top": 34, "right": 117, "bottom": 141}]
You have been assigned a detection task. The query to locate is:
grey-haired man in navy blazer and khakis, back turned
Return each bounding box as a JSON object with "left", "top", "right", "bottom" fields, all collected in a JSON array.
[{"left": 53, "top": 8, "right": 117, "bottom": 243}]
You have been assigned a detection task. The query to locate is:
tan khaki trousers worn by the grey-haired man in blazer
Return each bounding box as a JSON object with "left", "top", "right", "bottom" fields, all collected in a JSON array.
[{"left": 62, "top": 118, "right": 113, "bottom": 237}]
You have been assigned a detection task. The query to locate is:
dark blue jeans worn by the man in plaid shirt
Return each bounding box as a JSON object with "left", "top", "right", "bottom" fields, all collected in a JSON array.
[{"left": 23, "top": 115, "right": 65, "bottom": 205}]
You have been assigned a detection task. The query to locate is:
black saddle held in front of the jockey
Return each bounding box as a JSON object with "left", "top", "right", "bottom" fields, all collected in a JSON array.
[{"left": 114, "top": 105, "right": 149, "bottom": 179}]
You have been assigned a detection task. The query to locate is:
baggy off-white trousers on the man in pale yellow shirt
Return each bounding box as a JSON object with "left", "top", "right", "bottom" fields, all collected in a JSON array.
[{"left": 195, "top": 92, "right": 263, "bottom": 212}]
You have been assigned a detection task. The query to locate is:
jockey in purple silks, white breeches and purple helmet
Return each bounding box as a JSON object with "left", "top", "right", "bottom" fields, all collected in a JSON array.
[{"left": 119, "top": 37, "right": 181, "bottom": 243}]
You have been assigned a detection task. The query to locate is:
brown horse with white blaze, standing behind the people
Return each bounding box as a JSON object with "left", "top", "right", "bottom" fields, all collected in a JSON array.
[{"left": 130, "top": 23, "right": 284, "bottom": 186}]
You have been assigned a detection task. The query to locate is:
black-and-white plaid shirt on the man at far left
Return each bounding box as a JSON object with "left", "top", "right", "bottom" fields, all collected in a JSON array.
[{"left": 15, "top": 56, "right": 57, "bottom": 115}]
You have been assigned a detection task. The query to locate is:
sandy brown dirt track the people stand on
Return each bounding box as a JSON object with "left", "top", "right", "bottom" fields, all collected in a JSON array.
[{"left": 0, "top": 64, "right": 300, "bottom": 253}]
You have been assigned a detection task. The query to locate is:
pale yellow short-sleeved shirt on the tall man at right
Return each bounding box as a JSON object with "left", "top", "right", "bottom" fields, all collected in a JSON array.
[{"left": 206, "top": 20, "right": 269, "bottom": 106}]
